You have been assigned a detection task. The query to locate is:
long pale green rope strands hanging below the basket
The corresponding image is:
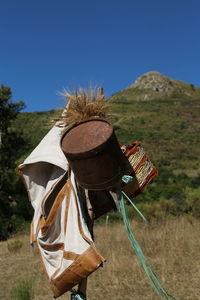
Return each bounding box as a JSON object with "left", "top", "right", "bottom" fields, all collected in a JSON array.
[{"left": 118, "top": 176, "right": 176, "bottom": 300}]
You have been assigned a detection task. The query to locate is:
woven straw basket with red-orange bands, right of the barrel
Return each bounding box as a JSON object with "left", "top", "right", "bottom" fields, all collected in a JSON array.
[{"left": 121, "top": 141, "right": 158, "bottom": 197}]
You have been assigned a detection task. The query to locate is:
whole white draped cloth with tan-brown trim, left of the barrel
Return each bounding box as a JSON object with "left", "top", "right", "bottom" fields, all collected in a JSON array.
[{"left": 17, "top": 126, "right": 104, "bottom": 297}]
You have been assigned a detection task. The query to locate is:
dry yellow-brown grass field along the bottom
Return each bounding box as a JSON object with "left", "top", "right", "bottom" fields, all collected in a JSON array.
[{"left": 0, "top": 217, "right": 200, "bottom": 300}]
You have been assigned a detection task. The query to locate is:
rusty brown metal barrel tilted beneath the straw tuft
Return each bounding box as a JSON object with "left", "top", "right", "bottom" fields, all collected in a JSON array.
[{"left": 61, "top": 118, "right": 124, "bottom": 190}]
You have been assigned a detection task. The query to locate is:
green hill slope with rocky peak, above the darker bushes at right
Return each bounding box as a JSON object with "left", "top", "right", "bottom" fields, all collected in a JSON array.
[{"left": 109, "top": 72, "right": 200, "bottom": 175}]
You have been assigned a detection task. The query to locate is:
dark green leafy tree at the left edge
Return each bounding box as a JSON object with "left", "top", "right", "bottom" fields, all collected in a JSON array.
[{"left": 0, "top": 85, "right": 25, "bottom": 237}]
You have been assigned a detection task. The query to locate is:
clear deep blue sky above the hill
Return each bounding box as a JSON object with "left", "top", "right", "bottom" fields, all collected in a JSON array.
[{"left": 0, "top": 0, "right": 200, "bottom": 111}]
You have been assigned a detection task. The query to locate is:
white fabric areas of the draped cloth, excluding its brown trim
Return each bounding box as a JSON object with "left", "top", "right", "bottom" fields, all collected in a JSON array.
[{"left": 18, "top": 126, "right": 93, "bottom": 278}]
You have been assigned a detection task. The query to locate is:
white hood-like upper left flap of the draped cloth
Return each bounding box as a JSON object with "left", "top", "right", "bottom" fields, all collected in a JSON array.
[{"left": 18, "top": 126, "right": 68, "bottom": 239}]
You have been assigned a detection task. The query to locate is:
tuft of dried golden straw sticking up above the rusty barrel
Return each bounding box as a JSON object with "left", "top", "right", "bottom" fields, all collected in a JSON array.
[{"left": 56, "top": 88, "right": 109, "bottom": 129}]
